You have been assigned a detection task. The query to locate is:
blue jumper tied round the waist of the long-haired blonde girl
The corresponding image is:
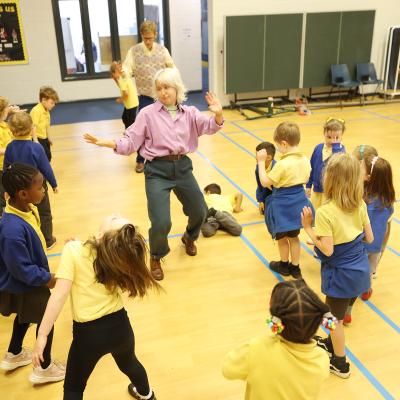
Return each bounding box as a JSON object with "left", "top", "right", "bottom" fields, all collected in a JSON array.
[{"left": 314, "top": 234, "right": 371, "bottom": 298}]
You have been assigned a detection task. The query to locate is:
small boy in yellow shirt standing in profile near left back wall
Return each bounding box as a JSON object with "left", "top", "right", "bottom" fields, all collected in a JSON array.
[{"left": 30, "top": 86, "right": 59, "bottom": 161}]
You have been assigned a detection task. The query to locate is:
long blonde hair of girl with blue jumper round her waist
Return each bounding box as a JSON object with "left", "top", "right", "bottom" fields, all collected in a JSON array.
[{"left": 324, "top": 153, "right": 363, "bottom": 212}]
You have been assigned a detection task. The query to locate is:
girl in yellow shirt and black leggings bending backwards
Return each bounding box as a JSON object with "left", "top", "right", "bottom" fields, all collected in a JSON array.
[{"left": 33, "top": 217, "right": 160, "bottom": 400}]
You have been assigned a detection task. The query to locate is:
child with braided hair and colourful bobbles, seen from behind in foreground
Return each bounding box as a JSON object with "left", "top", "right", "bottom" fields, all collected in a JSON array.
[{"left": 222, "top": 279, "right": 337, "bottom": 400}]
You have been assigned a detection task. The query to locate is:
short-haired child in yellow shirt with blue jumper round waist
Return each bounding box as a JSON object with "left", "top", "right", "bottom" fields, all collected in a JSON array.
[{"left": 257, "top": 122, "right": 311, "bottom": 279}]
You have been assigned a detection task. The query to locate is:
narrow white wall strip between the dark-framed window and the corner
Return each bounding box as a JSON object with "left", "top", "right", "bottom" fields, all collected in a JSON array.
[{"left": 169, "top": 0, "right": 202, "bottom": 90}]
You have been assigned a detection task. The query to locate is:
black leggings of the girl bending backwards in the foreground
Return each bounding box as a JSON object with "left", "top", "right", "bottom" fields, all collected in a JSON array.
[{"left": 64, "top": 309, "right": 150, "bottom": 400}]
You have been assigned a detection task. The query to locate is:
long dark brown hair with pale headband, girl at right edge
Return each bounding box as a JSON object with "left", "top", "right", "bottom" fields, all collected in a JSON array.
[{"left": 364, "top": 155, "right": 396, "bottom": 208}]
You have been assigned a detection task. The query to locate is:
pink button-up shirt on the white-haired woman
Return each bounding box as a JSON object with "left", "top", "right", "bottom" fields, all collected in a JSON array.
[{"left": 115, "top": 101, "right": 223, "bottom": 161}]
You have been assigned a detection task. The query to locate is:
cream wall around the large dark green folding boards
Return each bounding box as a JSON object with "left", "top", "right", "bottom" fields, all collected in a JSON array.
[{"left": 208, "top": 0, "right": 400, "bottom": 105}]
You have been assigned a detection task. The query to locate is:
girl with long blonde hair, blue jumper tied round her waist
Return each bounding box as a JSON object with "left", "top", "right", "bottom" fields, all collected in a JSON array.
[{"left": 302, "top": 153, "right": 374, "bottom": 378}]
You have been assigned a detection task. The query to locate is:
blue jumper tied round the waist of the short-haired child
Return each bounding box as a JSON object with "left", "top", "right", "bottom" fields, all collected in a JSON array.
[{"left": 265, "top": 185, "right": 314, "bottom": 239}]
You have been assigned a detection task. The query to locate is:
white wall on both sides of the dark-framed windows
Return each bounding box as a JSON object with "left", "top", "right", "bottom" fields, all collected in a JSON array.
[{"left": 0, "top": 0, "right": 201, "bottom": 104}]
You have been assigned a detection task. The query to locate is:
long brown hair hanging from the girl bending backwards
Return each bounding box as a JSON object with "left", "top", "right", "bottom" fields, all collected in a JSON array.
[{"left": 85, "top": 224, "right": 161, "bottom": 297}]
